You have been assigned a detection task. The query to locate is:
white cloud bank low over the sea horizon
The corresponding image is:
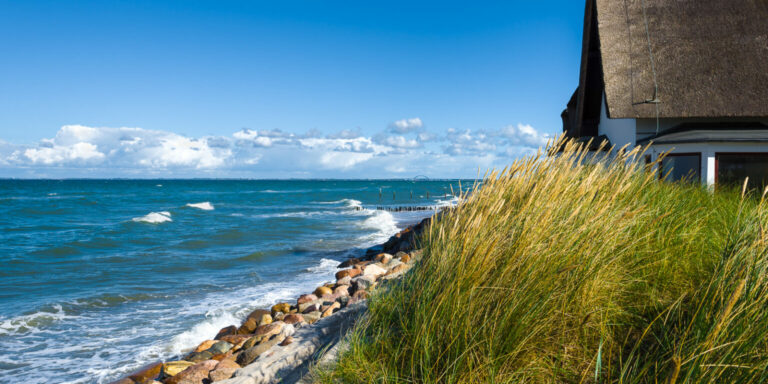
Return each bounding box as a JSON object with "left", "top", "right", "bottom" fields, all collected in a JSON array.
[{"left": 0, "top": 117, "right": 550, "bottom": 178}]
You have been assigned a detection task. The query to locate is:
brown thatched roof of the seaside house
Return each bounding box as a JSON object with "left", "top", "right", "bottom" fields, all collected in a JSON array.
[{"left": 596, "top": 0, "right": 768, "bottom": 118}]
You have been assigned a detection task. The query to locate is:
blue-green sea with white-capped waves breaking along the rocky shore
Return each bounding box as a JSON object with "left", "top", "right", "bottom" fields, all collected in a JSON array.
[{"left": 0, "top": 179, "right": 462, "bottom": 383}]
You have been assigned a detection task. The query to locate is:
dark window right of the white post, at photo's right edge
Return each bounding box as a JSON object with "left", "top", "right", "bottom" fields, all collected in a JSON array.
[{"left": 715, "top": 153, "right": 768, "bottom": 191}]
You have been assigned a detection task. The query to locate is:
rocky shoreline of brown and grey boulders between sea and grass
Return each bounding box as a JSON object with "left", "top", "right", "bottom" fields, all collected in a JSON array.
[{"left": 112, "top": 218, "right": 431, "bottom": 384}]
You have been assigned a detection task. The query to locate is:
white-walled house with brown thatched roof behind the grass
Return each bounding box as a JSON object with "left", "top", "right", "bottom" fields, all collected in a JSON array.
[{"left": 562, "top": 0, "right": 768, "bottom": 187}]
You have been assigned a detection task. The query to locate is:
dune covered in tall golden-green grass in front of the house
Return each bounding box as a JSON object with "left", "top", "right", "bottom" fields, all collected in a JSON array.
[{"left": 322, "top": 141, "right": 768, "bottom": 383}]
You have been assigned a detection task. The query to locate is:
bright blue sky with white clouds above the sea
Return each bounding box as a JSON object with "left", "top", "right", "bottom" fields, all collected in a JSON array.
[{"left": 0, "top": 0, "right": 584, "bottom": 178}]
